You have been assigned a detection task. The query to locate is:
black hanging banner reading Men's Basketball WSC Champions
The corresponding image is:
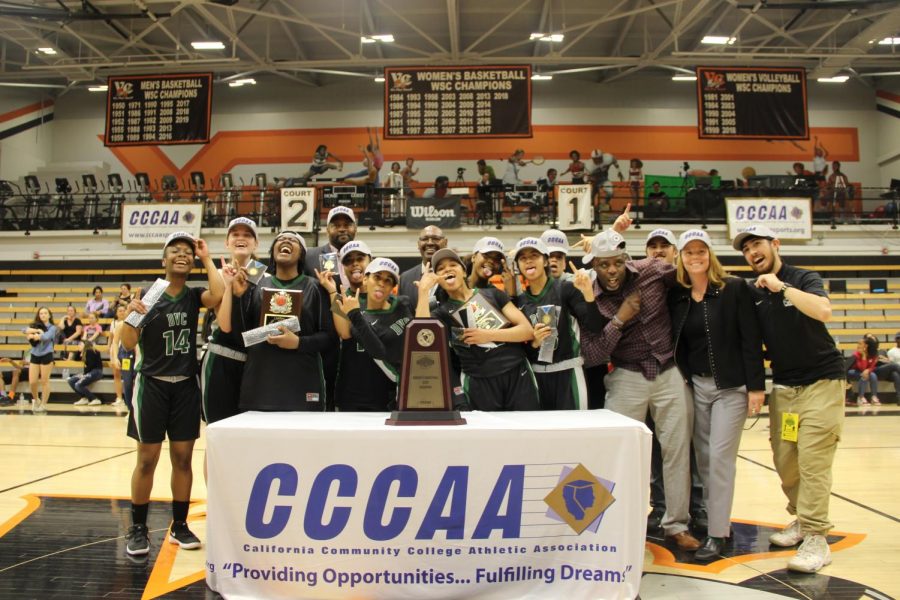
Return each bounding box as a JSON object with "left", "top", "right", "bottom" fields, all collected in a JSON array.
[{"left": 103, "top": 73, "right": 212, "bottom": 146}]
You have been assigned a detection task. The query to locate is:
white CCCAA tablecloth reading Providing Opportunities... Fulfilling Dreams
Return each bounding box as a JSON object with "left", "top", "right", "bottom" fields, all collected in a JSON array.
[{"left": 206, "top": 411, "right": 650, "bottom": 600}]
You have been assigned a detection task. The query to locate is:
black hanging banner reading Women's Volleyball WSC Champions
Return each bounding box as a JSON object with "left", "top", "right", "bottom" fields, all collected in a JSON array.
[{"left": 697, "top": 67, "right": 809, "bottom": 140}]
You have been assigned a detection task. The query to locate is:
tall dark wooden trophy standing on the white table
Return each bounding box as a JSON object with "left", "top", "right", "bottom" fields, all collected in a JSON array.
[{"left": 385, "top": 319, "right": 466, "bottom": 425}]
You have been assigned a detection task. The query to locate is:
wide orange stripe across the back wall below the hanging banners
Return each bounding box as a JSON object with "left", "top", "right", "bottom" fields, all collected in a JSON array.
[{"left": 101, "top": 125, "right": 859, "bottom": 185}]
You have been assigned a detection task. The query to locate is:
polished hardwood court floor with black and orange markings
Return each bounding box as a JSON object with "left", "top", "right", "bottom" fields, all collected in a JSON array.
[{"left": 0, "top": 403, "right": 900, "bottom": 600}]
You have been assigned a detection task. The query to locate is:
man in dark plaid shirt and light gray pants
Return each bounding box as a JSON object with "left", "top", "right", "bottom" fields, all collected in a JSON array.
[{"left": 582, "top": 229, "right": 700, "bottom": 551}]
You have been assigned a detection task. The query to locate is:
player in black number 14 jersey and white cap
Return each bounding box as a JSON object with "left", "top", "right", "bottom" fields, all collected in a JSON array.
[{"left": 121, "top": 232, "right": 225, "bottom": 556}]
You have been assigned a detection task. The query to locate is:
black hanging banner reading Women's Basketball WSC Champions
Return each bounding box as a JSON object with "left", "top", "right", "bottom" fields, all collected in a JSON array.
[{"left": 384, "top": 65, "right": 531, "bottom": 139}]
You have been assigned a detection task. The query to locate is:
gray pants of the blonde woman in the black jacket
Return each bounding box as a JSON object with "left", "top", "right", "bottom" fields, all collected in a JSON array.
[{"left": 693, "top": 376, "right": 747, "bottom": 537}]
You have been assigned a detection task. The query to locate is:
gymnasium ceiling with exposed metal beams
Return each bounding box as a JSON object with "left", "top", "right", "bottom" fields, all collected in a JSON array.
[{"left": 0, "top": 0, "right": 900, "bottom": 90}]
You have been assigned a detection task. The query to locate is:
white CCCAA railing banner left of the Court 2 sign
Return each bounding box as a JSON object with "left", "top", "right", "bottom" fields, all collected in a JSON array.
[{"left": 122, "top": 202, "right": 203, "bottom": 245}]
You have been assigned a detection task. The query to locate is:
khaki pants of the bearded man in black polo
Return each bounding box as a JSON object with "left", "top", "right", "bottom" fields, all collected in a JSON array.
[{"left": 769, "top": 379, "right": 844, "bottom": 535}]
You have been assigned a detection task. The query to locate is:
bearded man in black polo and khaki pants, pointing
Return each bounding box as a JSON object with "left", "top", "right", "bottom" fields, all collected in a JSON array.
[{"left": 732, "top": 225, "right": 846, "bottom": 573}]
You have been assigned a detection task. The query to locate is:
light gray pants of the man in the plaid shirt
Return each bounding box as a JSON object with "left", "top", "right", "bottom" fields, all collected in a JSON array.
[{"left": 605, "top": 367, "right": 693, "bottom": 535}]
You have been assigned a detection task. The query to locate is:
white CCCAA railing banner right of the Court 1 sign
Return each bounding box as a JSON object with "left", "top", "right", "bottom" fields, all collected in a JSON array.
[{"left": 725, "top": 198, "right": 812, "bottom": 240}]
